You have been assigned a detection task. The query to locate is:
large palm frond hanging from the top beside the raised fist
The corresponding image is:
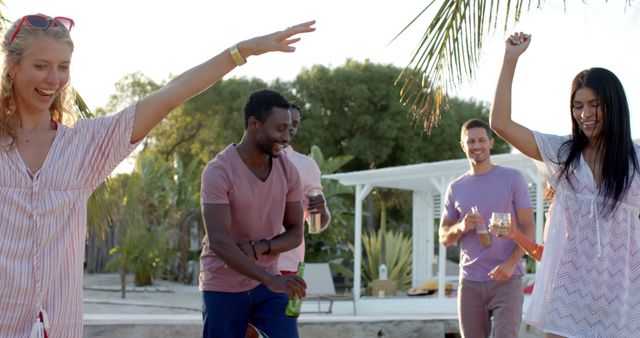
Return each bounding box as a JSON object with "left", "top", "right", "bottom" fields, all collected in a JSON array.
[{"left": 395, "top": 0, "right": 540, "bottom": 132}]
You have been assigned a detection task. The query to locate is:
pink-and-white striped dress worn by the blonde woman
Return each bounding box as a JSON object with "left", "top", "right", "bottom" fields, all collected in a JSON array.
[{"left": 0, "top": 105, "right": 141, "bottom": 338}]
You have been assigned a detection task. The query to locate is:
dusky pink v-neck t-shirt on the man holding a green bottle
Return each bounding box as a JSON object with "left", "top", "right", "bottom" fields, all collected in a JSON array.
[{"left": 200, "top": 145, "right": 303, "bottom": 292}]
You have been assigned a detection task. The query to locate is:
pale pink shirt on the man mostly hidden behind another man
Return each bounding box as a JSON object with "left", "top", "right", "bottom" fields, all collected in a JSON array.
[{"left": 278, "top": 147, "right": 322, "bottom": 271}]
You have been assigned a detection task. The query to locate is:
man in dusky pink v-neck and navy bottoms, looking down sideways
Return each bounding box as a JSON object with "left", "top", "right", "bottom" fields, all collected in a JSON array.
[{"left": 199, "top": 90, "right": 306, "bottom": 338}]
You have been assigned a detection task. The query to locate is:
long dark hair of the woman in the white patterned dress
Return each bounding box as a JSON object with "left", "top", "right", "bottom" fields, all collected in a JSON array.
[{"left": 558, "top": 68, "right": 638, "bottom": 214}]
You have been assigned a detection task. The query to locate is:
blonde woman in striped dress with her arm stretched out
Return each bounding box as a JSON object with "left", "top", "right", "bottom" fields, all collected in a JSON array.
[{"left": 0, "top": 14, "right": 314, "bottom": 337}]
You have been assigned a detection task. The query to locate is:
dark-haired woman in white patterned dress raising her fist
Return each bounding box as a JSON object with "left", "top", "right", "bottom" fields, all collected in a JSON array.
[{"left": 491, "top": 33, "right": 640, "bottom": 337}]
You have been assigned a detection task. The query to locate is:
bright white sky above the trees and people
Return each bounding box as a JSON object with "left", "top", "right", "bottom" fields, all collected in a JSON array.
[{"left": 2, "top": 0, "right": 640, "bottom": 138}]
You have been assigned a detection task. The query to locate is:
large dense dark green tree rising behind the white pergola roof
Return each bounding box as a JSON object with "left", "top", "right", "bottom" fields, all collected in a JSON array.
[{"left": 293, "top": 60, "right": 509, "bottom": 170}]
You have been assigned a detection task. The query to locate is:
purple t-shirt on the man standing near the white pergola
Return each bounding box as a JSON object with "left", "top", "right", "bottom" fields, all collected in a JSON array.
[{"left": 442, "top": 166, "right": 531, "bottom": 281}]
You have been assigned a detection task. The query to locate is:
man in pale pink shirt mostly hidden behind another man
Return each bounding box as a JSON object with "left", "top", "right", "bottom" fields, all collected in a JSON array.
[{"left": 278, "top": 104, "right": 331, "bottom": 275}]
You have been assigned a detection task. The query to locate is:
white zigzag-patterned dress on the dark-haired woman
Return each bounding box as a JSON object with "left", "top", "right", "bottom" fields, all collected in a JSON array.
[{"left": 525, "top": 133, "right": 640, "bottom": 337}]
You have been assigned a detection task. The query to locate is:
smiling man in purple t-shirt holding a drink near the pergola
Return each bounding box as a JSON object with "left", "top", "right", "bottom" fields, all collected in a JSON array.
[{"left": 440, "top": 119, "right": 535, "bottom": 338}]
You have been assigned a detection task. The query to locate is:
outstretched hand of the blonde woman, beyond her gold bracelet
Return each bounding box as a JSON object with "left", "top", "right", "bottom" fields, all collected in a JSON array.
[{"left": 238, "top": 20, "right": 316, "bottom": 59}]
